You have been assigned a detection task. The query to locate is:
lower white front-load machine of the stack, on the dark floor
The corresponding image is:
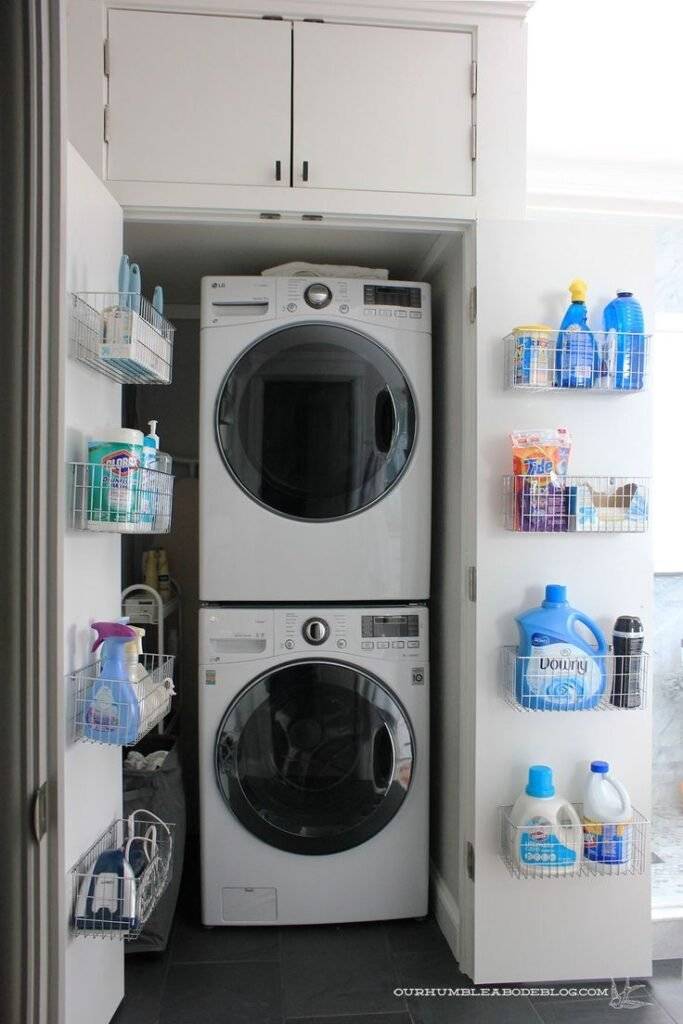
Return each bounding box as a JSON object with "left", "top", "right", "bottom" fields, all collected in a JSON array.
[{"left": 200, "top": 605, "right": 429, "bottom": 925}]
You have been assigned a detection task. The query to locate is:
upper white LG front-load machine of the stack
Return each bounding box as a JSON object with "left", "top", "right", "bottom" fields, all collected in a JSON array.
[{"left": 200, "top": 276, "right": 432, "bottom": 603}]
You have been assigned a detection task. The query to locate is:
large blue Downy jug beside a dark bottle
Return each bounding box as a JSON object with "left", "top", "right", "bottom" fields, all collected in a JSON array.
[{"left": 515, "top": 584, "right": 608, "bottom": 711}]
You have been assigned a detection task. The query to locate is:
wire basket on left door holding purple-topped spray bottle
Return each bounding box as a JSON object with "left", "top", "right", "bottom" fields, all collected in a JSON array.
[{"left": 70, "top": 654, "right": 175, "bottom": 746}]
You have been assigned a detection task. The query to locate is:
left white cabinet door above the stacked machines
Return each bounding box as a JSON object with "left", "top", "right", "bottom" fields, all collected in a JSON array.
[{"left": 108, "top": 10, "right": 292, "bottom": 186}]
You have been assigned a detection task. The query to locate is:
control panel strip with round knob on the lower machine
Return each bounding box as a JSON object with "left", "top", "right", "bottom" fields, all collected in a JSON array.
[{"left": 200, "top": 604, "right": 429, "bottom": 665}]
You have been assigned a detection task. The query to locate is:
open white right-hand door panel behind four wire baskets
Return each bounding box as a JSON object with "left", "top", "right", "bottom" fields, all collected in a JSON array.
[{"left": 471, "top": 219, "right": 654, "bottom": 982}]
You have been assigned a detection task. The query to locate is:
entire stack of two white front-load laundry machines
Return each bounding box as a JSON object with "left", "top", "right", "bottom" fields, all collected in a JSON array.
[{"left": 199, "top": 276, "right": 431, "bottom": 925}]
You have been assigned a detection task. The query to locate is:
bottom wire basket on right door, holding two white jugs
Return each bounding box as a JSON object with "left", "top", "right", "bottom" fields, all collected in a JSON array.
[{"left": 499, "top": 804, "right": 649, "bottom": 879}]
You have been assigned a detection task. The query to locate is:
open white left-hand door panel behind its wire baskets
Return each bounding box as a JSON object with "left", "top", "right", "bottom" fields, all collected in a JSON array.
[{"left": 63, "top": 146, "right": 123, "bottom": 1024}]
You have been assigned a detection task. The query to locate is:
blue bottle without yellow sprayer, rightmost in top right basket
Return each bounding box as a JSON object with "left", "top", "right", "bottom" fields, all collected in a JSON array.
[{"left": 602, "top": 289, "right": 645, "bottom": 391}]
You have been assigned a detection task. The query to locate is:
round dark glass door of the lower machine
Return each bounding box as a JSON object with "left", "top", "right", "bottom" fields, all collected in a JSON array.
[{"left": 216, "top": 660, "right": 415, "bottom": 854}]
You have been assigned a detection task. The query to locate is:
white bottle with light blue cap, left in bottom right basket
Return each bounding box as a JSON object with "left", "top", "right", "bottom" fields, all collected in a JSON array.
[{"left": 509, "top": 765, "right": 583, "bottom": 876}]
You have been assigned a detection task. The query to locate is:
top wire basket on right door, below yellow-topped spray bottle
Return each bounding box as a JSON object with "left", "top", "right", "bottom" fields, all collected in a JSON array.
[{"left": 504, "top": 325, "right": 650, "bottom": 394}]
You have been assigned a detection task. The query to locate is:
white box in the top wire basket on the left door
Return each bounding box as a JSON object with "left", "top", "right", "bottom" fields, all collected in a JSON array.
[{"left": 100, "top": 305, "right": 172, "bottom": 384}]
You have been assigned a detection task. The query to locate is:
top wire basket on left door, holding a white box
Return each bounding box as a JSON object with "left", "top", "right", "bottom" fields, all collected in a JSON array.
[{"left": 71, "top": 292, "right": 175, "bottom": 384}]
